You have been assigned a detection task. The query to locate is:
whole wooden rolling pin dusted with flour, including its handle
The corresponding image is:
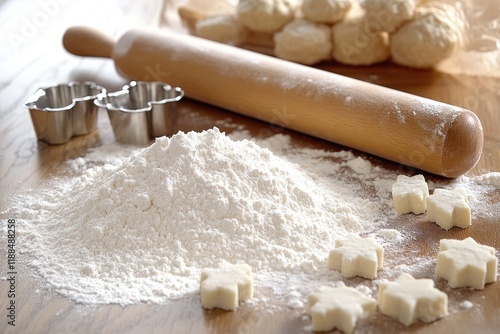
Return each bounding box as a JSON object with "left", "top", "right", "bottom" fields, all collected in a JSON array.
[{"left": 63, "top": 27, "right": 483, "bottom": 177}]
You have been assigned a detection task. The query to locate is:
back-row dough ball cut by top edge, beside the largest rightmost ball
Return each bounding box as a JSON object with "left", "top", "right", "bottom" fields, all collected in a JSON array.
[{"left": 361, "top": 0, "right": 417, "bottom": 32}]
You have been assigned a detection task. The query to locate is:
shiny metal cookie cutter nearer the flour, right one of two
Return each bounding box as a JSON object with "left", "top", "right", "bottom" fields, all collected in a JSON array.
[{"left": 95, "top": 81, "right": 184, "bottom": 145}]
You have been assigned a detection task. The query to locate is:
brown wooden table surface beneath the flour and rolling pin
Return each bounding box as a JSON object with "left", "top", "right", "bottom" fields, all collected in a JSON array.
[{"left": 0, "top": 0, "right": 500, "bottom": 333}]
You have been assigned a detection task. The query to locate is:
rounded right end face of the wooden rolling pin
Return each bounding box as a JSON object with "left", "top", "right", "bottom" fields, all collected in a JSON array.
[{"left": 438, "top": 110, "right": 484, "bottom": 178}]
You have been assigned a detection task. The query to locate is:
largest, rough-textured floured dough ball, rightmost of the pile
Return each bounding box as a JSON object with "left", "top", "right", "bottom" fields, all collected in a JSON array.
[{"left": 390, "top": 2, "right": 464, "bottom": 68}]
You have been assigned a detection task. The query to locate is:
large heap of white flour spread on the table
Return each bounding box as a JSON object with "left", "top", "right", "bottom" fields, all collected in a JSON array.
[{"left": 2, "top": 128, "right": 496, "bottom": 308}]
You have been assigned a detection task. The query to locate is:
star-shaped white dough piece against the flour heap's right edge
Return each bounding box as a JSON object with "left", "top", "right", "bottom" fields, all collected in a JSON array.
[{"left": 328, "top": 235, "right": 384, "bottom": 279}]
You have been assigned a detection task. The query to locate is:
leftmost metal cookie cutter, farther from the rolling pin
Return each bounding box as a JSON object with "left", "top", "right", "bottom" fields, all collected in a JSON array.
[{"left": 23, "top": 81, "right": 106, "bottom": 144}]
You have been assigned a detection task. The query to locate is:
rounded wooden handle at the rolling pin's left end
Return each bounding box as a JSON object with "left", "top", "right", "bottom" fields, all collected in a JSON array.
[{"left": 63, "top": 26, "right": 115, "bottom": 58}]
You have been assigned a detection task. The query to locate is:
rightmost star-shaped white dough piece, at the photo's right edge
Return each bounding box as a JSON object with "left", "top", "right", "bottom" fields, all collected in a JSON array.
[{"left": 436, "top": 237, "right": 498, "bottom": 290}]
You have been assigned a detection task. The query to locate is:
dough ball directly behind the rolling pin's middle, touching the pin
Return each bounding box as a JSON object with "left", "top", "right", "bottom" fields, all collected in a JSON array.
[{"left": 274, "top": 19, "right": 332, "bottom": 65}]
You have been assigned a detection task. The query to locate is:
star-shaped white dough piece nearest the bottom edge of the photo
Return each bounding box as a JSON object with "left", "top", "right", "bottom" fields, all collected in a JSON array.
[{"left": 307, "top": 286, "right": 377, "bottom": 333}]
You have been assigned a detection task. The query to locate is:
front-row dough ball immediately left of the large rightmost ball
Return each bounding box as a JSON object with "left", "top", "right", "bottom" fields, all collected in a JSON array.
[{"left": 332, "top": 11, "right": 390, "bottom": 65}]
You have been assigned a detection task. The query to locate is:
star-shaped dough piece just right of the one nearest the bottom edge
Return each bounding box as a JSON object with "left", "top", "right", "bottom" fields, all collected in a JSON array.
[{"left": 378, "top": 273, "right": 448, "bottom": 326}]
